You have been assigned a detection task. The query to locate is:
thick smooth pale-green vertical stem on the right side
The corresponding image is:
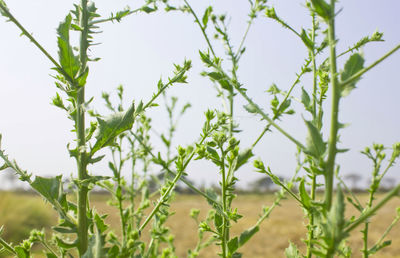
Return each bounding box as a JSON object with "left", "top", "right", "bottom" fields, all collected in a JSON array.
[{"left": 325, "top": 0, "right": 340, "bottom": 210}]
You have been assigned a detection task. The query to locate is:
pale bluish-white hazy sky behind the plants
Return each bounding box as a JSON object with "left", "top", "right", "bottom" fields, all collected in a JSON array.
[{"left": 0, "top": 0, "right": 400, "bottom": 189}]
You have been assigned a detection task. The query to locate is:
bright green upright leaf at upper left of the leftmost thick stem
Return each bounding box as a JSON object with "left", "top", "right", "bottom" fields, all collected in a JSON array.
[{"left": 57, "top": 14, "right": 80, "bottom": 79}]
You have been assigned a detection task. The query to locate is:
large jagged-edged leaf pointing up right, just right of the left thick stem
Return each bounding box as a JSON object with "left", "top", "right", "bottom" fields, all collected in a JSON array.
[{"left": 91, "top": 103, "right": 135, "bottom": 156}]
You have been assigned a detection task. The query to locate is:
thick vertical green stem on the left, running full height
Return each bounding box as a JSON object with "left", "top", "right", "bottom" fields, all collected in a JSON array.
[{"left": 75, "top": 0, "right": 89, "bottom": 257}]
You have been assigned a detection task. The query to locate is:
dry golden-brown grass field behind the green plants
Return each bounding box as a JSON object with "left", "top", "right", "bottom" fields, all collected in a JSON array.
[{"left": 0, "top": 193, "right": 400, "bottom": 258}]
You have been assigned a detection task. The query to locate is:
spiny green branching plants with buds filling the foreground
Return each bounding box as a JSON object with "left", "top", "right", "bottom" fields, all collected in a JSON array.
[{"left": 0, "top": 0, "right": 400, "bottom": 257}]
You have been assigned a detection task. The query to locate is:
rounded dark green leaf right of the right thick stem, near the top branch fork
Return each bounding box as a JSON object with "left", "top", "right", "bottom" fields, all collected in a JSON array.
[{"left": 340, "top": 53, "right": 365, "bottom": 97}]
